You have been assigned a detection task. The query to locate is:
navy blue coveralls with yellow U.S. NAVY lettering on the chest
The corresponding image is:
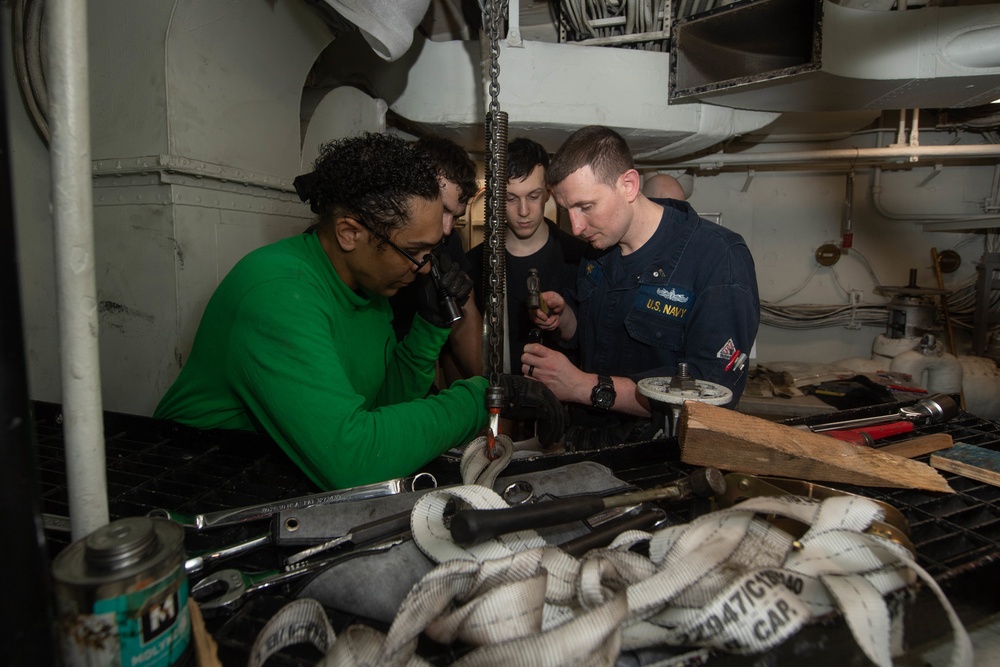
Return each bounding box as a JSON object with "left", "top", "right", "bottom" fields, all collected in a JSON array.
[{"left": 575, "top": 199, "right": 760, "bottom": 444}]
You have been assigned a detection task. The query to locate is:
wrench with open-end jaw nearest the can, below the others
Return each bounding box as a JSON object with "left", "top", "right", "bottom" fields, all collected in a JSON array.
[{"left": 191, "top": 531, "right": 410, "bottom": 612}]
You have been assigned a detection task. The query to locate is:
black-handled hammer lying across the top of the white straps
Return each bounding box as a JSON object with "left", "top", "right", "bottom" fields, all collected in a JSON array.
[{"left": 449, "top": 468, "right": 726, "bottom": 546}]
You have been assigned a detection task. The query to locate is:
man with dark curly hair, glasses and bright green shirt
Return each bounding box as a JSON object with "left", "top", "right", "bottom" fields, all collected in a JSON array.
[{"left": 155, "top": 134, "right": 520, "bottom": 488}]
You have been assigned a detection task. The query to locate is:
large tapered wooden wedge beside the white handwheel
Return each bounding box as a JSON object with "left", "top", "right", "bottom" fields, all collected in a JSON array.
[{"left": 677, "top": 401, "right": 954, "bottom": 493}]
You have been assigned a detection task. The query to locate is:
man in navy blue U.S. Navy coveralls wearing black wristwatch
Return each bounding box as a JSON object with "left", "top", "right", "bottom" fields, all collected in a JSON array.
[{"left": 521, "top": 126, "right": 760, "bottom": 448}]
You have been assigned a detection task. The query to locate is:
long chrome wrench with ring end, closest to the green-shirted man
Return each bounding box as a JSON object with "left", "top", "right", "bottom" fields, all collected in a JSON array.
[{"left": 146, "top": 472, "right": 437, "bottom": 530}]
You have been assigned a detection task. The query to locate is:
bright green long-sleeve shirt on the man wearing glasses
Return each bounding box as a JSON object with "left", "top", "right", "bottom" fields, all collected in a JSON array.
[{"left": 155, "top": 234, "right": 487, "bottom": 488}]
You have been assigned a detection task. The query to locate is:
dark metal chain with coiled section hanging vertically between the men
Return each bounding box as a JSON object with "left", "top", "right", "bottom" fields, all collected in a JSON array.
[{"left": 483, "top": 0, "right": 507, "bottom": 386}]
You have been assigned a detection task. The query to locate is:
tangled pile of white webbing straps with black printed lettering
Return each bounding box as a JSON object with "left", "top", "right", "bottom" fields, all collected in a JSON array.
[{"left": 252, "top": 486, "right": 972, "bottom": 667}]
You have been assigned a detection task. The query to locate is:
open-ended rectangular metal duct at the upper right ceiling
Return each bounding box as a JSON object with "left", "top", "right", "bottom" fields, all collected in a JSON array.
[{"left": 670, "top": 0, "right": 1000, "bottom": 111}]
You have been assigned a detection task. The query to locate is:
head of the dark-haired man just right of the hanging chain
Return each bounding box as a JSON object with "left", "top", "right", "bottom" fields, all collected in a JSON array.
[{"left": 507, "top": 137, "right": 549, "bottom": 239}]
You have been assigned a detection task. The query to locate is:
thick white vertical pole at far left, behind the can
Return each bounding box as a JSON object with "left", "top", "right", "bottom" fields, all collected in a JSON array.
[{"left": 45, "top": 0, "right": 108, "bottom": 541}]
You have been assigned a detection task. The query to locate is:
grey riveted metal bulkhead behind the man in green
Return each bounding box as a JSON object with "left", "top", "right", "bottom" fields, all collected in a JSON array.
[{"left": 83, "top": 0, "right": 333, "bottom": 414}]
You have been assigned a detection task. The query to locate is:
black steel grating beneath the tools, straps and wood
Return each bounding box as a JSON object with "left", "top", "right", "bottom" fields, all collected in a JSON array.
[{"left": 27, "top": 396, "right": 1000, "bottom": 665}]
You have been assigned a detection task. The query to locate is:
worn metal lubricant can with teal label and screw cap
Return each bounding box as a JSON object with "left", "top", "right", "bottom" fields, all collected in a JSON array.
[{"left": 52, "top": 517, "right": 194, "bottom": 667}]
